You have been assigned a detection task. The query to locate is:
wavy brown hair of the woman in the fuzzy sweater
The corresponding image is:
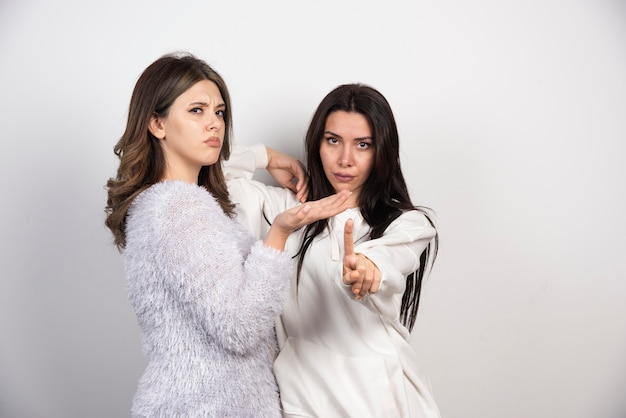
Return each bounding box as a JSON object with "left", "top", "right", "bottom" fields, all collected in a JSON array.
[{"left": 105, "top": 53, "right": 234, "bottom": 251}]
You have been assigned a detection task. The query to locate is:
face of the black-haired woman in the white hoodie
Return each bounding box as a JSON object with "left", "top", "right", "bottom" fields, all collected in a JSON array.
[{"left": 320, "top": 110, "right": 374, "bottom": 207}]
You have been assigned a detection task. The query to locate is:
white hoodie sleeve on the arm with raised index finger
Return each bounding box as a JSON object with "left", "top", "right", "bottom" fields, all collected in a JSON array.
[{"left": 354, "top": 210, "right": 436, "bottom": 319}]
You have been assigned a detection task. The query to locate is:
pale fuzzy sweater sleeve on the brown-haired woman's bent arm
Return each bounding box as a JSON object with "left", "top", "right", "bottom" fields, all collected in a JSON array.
[{"left": 154, "top": 185, "right": 291, "bottom": 353}]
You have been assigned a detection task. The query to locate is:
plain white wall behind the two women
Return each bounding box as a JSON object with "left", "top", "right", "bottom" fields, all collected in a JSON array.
[{"left": 0, "top": 0, "right": 626, "bottom": 418}]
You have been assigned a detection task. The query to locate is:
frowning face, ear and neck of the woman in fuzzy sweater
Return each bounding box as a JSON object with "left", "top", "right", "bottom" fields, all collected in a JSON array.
[{"left": 150, "top": 80, "right": 226, "bottom": 183}]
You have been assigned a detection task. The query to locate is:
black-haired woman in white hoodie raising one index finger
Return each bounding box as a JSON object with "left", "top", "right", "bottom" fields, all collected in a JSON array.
[{"left": 226, "top": 84, "right": 440, "bottom": 418}]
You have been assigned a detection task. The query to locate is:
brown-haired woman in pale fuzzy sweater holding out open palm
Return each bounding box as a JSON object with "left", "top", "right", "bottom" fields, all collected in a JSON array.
[{"left": 106, "top": 55, "right": 349, "bottom": 418}]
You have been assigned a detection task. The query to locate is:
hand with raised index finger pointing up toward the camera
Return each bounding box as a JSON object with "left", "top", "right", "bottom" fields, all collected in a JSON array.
[{"left": 343, "top": 219, "right": 381, "bottom": 300}]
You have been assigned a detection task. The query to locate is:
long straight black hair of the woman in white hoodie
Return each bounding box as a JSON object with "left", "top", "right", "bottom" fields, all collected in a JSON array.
[{"left": 296, "top": 84, "right": 439, "bottom": 331}]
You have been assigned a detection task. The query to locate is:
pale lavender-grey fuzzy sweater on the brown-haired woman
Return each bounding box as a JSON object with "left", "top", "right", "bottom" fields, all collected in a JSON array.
[{"left": 124, "top": 181, "right": 291, "bottom": 418}]
